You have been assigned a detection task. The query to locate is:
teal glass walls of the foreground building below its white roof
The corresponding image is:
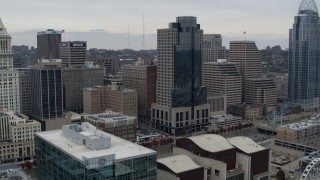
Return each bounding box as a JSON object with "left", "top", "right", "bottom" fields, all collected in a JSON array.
[{"left": 35, "top": 136, "right": 157, "bottom": 180}]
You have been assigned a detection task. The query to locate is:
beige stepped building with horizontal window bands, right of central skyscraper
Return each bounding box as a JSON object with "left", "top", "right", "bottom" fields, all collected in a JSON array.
[{"left": 202, "top": 61, "right": 242, "bottom": 106}]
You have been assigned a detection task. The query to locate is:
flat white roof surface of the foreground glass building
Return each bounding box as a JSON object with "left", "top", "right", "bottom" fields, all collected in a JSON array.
[{"left": 36, "top": 129, "right": 156, "bottom": 163}]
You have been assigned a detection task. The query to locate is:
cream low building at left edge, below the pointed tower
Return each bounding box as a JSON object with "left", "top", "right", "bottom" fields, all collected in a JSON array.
[{"left": 0, "top": 111, "right": 41, "bottom": 163}]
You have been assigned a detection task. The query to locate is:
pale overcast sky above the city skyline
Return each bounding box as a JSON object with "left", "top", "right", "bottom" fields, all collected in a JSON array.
[{"left": 0, "top": 0, "right": 320, "bottom": 50}]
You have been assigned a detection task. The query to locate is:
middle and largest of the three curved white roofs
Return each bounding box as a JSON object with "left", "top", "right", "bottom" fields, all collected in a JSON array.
[{"left": 188, "top": 134, "right": 234, "bottom": 152}]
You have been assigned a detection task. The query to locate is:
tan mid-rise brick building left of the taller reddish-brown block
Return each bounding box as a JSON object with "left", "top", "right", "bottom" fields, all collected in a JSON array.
[{"left": 83, "top": 83, "right": 137, "bottom": 117}]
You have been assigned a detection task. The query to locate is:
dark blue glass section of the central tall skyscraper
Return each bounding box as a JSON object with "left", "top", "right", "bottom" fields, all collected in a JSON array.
[{"left": 171, "top": 17, "right": 207, "bottom": 107}]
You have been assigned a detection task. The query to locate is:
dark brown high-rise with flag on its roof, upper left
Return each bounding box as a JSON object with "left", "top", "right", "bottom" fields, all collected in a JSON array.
[{"left": 37, "top": 29, "right": 62, "bottom": 59}]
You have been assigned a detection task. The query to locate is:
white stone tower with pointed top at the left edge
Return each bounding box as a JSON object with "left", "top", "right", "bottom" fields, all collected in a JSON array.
[{"left": 0, "top": 19, "right": 20, "bottom": 113}]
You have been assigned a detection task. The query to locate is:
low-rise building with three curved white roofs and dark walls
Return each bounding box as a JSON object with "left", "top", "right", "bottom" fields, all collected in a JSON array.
[{"left": 158, "top": 134, "right": 270, "bottom": 180}]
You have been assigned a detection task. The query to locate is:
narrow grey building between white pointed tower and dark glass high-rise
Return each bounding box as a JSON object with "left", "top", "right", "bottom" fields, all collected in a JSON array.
[{"left": 17, "top": 68, "right": 31, "bottom": 115}]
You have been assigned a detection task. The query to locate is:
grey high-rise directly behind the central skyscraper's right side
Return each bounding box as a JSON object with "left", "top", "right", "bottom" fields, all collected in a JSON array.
[{"left": 202, "top": 34, "right": 226, "bottom": 63}]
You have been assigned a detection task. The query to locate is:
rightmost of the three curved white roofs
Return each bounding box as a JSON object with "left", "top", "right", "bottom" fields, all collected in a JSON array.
[{"left": 228, "top": 136, "right": 266, "bottom": 154}]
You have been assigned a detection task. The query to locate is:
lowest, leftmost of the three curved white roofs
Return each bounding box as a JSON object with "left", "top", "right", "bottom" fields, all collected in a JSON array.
[{"left": 158, "top": 155, "right": 201, "bottom": 174}]
